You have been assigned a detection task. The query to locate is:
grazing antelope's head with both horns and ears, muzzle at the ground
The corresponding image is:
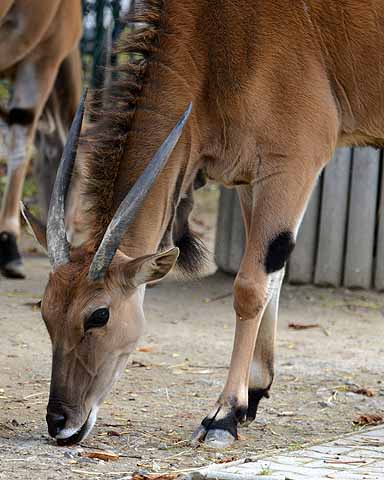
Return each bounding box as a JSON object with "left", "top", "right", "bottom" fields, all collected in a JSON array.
[{"left": 23, "top": 94, "right": 191, "bottom": 444}]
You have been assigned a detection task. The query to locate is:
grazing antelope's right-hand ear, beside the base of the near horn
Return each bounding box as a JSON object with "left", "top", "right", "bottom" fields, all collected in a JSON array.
[{"left": 125, "top": 247, "right": 180, "bottom": 287}]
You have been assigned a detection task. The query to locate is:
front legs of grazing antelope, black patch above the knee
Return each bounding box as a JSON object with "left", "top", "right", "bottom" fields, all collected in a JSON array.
[{"left": 193, "top": 159, "right": 320, "bottom": 448}]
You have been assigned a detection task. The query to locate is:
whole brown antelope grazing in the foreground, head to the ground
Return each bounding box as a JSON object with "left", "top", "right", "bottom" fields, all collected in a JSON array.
[{"left": 26, "top": 0, "right": 384, "bottom": 447}]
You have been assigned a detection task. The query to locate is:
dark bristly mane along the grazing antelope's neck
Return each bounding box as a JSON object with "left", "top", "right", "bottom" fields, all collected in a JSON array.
[{"left": 82, "top": 0, "right": 164, "bottom": 246}]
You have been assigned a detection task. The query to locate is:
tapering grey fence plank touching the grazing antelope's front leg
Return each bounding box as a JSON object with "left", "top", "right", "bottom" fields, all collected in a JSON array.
[{"left": 288, "top": 179, "right": 321, "bottom": 284}]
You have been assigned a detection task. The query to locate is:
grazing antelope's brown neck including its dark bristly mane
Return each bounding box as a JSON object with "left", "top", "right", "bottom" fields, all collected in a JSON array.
[{"left": 82, "top": 0, "right": 206, "bottom": 268}]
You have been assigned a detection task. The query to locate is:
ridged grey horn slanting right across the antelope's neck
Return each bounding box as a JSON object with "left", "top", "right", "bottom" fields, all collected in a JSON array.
[{"left": 88, "top": 103, "right": 192, "bottom": 281}]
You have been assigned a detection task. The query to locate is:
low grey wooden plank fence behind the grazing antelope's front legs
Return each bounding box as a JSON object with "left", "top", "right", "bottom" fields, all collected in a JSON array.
[{"left": 216, "top": 148, "right": 384, "bottom": 290}]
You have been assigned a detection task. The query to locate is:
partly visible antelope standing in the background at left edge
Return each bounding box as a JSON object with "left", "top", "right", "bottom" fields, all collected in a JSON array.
[{"left": 0, "top": 0, "right": 82, "bottom": 277}]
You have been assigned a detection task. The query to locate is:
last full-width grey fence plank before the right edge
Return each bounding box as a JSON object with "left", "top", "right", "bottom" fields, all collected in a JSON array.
[{"left": 344, "top": 148, "right": 380, "bottom": 288}]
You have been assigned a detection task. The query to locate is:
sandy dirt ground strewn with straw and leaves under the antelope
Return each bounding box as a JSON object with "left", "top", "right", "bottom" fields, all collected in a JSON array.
[{"left": 0, "top": 189, "right": 384, "bottom": 480}]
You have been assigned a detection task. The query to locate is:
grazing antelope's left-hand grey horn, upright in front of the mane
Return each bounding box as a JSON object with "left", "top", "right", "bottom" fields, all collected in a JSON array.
[{"left": 47, "top": 91, "right": 87, "bottom": 268}]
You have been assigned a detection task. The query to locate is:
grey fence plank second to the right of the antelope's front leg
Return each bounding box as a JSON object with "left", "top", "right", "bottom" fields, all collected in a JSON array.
[{"left": 315, "top": 148, "right": 352, "bottom": 287}]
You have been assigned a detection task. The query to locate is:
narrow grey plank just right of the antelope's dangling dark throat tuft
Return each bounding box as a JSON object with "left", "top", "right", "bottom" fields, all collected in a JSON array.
[{"left": 215, "top": 187, "right": 237, "bottom": 272}]
